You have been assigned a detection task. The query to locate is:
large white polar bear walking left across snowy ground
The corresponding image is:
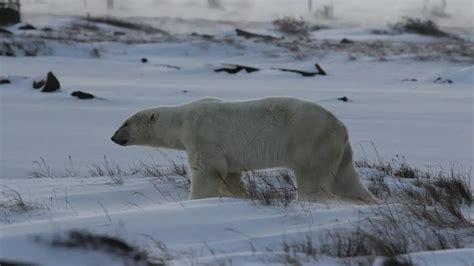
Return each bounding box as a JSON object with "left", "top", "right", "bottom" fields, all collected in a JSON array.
[{"left": 111, "top": 97, "right": 375, "bottom": 203}]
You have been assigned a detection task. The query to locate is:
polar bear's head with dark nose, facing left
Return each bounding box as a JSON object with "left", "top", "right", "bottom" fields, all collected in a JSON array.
[{"left": 111, "top": 109, "right": 160, "bottom": 146}]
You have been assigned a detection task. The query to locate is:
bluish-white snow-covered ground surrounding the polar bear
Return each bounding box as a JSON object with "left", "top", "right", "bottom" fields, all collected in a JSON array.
[{"left": 0, "top": 5, "right": 474, "bottom": 265}]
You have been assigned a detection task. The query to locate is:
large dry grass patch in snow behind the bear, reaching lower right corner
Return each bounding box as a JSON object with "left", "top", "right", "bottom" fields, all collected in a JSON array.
[{"left": 283, "top": 159, "right": 474, "bottom": 265}]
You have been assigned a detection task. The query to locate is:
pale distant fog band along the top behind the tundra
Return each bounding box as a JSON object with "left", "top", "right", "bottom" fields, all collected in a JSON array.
[{"left": 21, "top": 0, "right": 474, "bottom": 29}]
